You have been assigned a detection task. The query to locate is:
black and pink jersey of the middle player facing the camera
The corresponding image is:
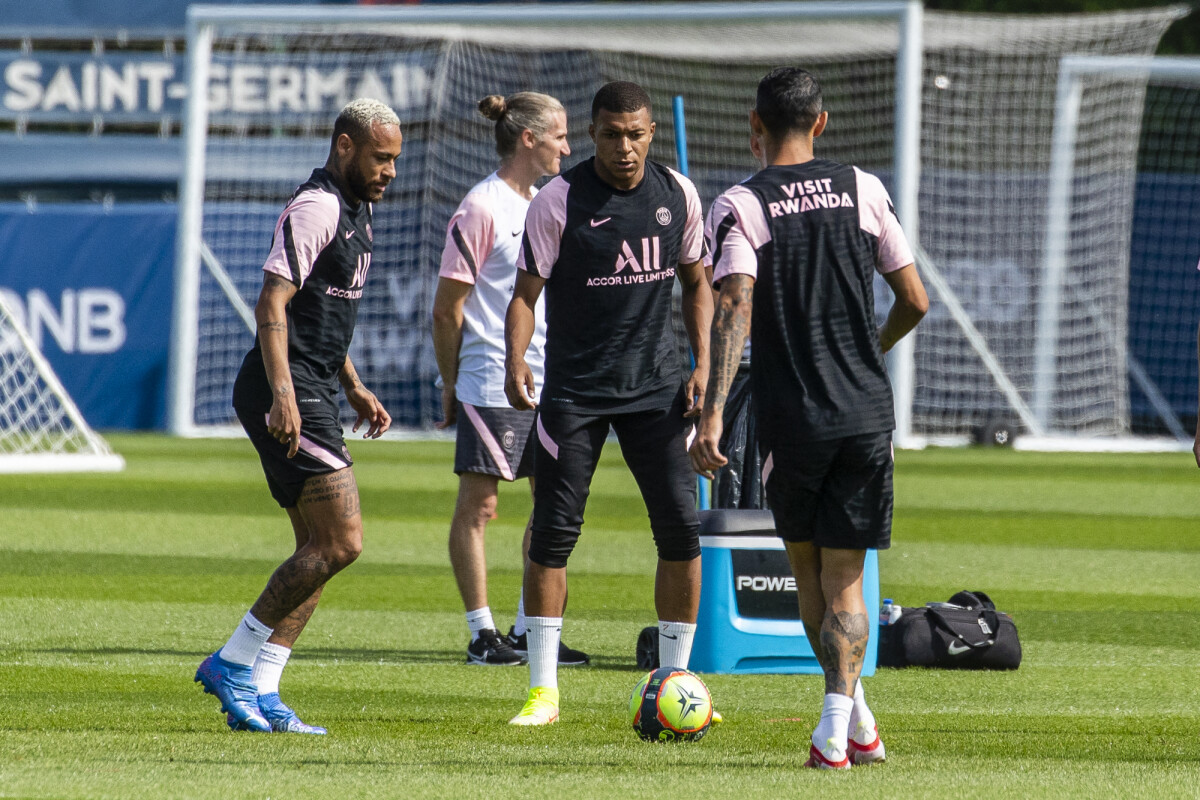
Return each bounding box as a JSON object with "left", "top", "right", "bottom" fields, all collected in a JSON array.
[{"left": 517, "top": 158, "right": 706, "bottom": 413}]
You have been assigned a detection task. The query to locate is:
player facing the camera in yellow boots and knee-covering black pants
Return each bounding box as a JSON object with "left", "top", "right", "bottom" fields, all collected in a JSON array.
[{"left": 504, "top": 82, "right": 713, "bottom": 726}]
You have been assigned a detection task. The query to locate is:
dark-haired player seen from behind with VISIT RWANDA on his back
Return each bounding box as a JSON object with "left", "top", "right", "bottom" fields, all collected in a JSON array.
[{"left": 690, "top": 67, "right": 929, "bottom": 769}]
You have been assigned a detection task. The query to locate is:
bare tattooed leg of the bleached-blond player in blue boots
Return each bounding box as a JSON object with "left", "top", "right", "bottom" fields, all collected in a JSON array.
[{"left": 251, "top": 468, "right": 362, "bottom": 638}]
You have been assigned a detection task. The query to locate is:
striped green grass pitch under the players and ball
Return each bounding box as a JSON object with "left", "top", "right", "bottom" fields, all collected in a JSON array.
[{"left": 0, "top": 435, "right": 1200, "bottom": 800}]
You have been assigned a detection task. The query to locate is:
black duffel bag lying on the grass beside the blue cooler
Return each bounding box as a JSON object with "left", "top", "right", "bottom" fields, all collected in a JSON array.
[{"left": 878, "top": 591, "right": 1021, "bottom": 669}]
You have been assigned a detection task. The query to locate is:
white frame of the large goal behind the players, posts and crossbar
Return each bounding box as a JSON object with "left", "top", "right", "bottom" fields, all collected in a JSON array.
[{"left": 167, "top": 0, "right": 924, "bottom": 438}]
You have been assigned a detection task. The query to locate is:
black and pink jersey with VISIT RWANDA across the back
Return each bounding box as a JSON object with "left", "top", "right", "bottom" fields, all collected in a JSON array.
[{"left": 706, "top": 158, "right": 913, "bottom": 449}]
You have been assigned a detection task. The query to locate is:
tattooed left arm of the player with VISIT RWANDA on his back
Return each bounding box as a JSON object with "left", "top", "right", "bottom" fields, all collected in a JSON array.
[{"left": 689, "top": 272, "right": 755, "bottom": 477}]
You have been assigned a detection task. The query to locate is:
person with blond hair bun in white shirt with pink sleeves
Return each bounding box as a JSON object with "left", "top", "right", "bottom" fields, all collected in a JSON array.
[{"left": 433, "top": 91, "right": 588, "bottom": 664}]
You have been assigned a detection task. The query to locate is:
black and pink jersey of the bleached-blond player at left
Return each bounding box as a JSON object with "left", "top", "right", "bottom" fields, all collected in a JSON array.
[{"left": 234, "top": 169, "right": 372, "bottom": 408}]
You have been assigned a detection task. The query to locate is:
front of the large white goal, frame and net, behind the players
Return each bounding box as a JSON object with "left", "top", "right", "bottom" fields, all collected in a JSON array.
[{"left": 168, "top": 0, "right": 923, "bottom": 438}]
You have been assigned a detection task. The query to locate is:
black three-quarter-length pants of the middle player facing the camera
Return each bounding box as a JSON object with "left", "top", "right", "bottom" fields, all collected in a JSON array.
[{"left": 529, "top": 391, "right": 700, "bottom": 567}]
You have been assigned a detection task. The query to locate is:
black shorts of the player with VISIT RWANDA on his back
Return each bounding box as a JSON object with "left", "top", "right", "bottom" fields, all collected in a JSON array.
[{"left": 762, "top": 432, "right": 893, "bottom": 551}]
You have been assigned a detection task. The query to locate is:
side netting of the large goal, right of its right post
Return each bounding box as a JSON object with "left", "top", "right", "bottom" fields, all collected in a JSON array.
[{"left": 913, "top": 7, "right": 1186, "bottom": 449}]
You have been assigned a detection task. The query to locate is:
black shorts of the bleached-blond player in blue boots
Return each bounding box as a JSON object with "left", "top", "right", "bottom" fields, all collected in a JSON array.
[{"left": 234, "top": 399, "right": 354, "bottom": 509}]
